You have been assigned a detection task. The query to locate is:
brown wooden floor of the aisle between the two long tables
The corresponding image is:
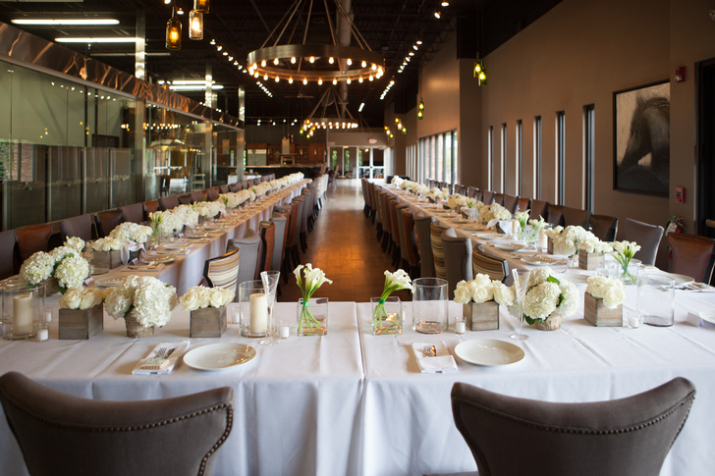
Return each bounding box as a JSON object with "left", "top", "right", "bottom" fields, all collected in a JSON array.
[{"left": 278, "top": 180, "right": 410, "bottom": 302}]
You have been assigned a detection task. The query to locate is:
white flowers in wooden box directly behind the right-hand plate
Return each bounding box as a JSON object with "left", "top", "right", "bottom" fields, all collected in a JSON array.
[{"left": 454, "top": 274, "right": 515, "bottom": 331}]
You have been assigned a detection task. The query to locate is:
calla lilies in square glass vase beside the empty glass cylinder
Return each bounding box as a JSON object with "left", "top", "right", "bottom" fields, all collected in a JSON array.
[{"left": 370, "top": 269, "right": 414, "bottom": 335}]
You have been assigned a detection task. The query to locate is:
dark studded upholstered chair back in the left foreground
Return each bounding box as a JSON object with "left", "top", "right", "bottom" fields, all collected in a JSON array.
[{"left": 0, "top": 372, "right": 234, "bottom": 476}]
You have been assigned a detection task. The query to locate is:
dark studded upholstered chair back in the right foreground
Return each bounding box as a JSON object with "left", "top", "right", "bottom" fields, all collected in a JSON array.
[{"left": 452, "top": 378, "right": 695, "bottom": 476}]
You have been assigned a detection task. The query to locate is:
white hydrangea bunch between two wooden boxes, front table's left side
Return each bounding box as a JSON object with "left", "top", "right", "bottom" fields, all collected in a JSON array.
[{"left": 104, "top": 276, "right": 178, "bottom": 327}]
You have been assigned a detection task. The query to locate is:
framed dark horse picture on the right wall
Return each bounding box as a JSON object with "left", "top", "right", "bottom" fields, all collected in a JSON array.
[{"left": 613, "top": 80, "right": 670, "bottom": 196}]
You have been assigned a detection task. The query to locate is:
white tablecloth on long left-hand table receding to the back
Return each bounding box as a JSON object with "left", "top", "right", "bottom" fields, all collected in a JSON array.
[{"left": 94, "top": 179, "right": 311, "bottom": 296}]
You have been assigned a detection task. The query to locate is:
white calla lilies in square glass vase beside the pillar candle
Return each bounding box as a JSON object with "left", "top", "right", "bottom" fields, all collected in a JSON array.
[{"left": 293, "top": 263, "right": 333, "bottom": 336}]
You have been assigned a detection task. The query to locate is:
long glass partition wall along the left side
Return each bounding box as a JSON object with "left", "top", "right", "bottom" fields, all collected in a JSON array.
[{"left": 0, "top": 62, "right": 243, "bottom": 230}]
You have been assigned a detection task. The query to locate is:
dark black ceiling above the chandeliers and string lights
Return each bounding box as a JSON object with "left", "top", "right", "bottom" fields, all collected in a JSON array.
[{"left": 0, "top": 0, "right": 558, "bottom": 127}]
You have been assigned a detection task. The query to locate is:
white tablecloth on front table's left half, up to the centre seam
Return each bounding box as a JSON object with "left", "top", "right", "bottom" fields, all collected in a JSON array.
[{"left": 0, "top": 298, "right": 364, "bottom": 476}]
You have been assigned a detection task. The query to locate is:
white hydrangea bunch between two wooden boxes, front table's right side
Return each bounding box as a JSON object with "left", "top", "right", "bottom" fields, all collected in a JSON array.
[{"left": 509, "top": 268, "right": 578, "bottom": 325}]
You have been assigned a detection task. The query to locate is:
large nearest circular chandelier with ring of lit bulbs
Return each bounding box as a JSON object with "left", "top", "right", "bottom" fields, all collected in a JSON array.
[{"left": 247, "top": 0, "right": 385, "bottom": 85}]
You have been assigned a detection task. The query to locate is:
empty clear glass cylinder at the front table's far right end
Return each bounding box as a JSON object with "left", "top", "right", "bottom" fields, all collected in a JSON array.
[{"left": 638, "top": 273, "right": 675, "bottom": 327}]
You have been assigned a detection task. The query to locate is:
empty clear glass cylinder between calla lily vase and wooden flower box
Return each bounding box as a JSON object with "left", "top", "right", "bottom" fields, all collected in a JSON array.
[{"left": 412, "top": 278, "right": 449, "bottom": 334}]
